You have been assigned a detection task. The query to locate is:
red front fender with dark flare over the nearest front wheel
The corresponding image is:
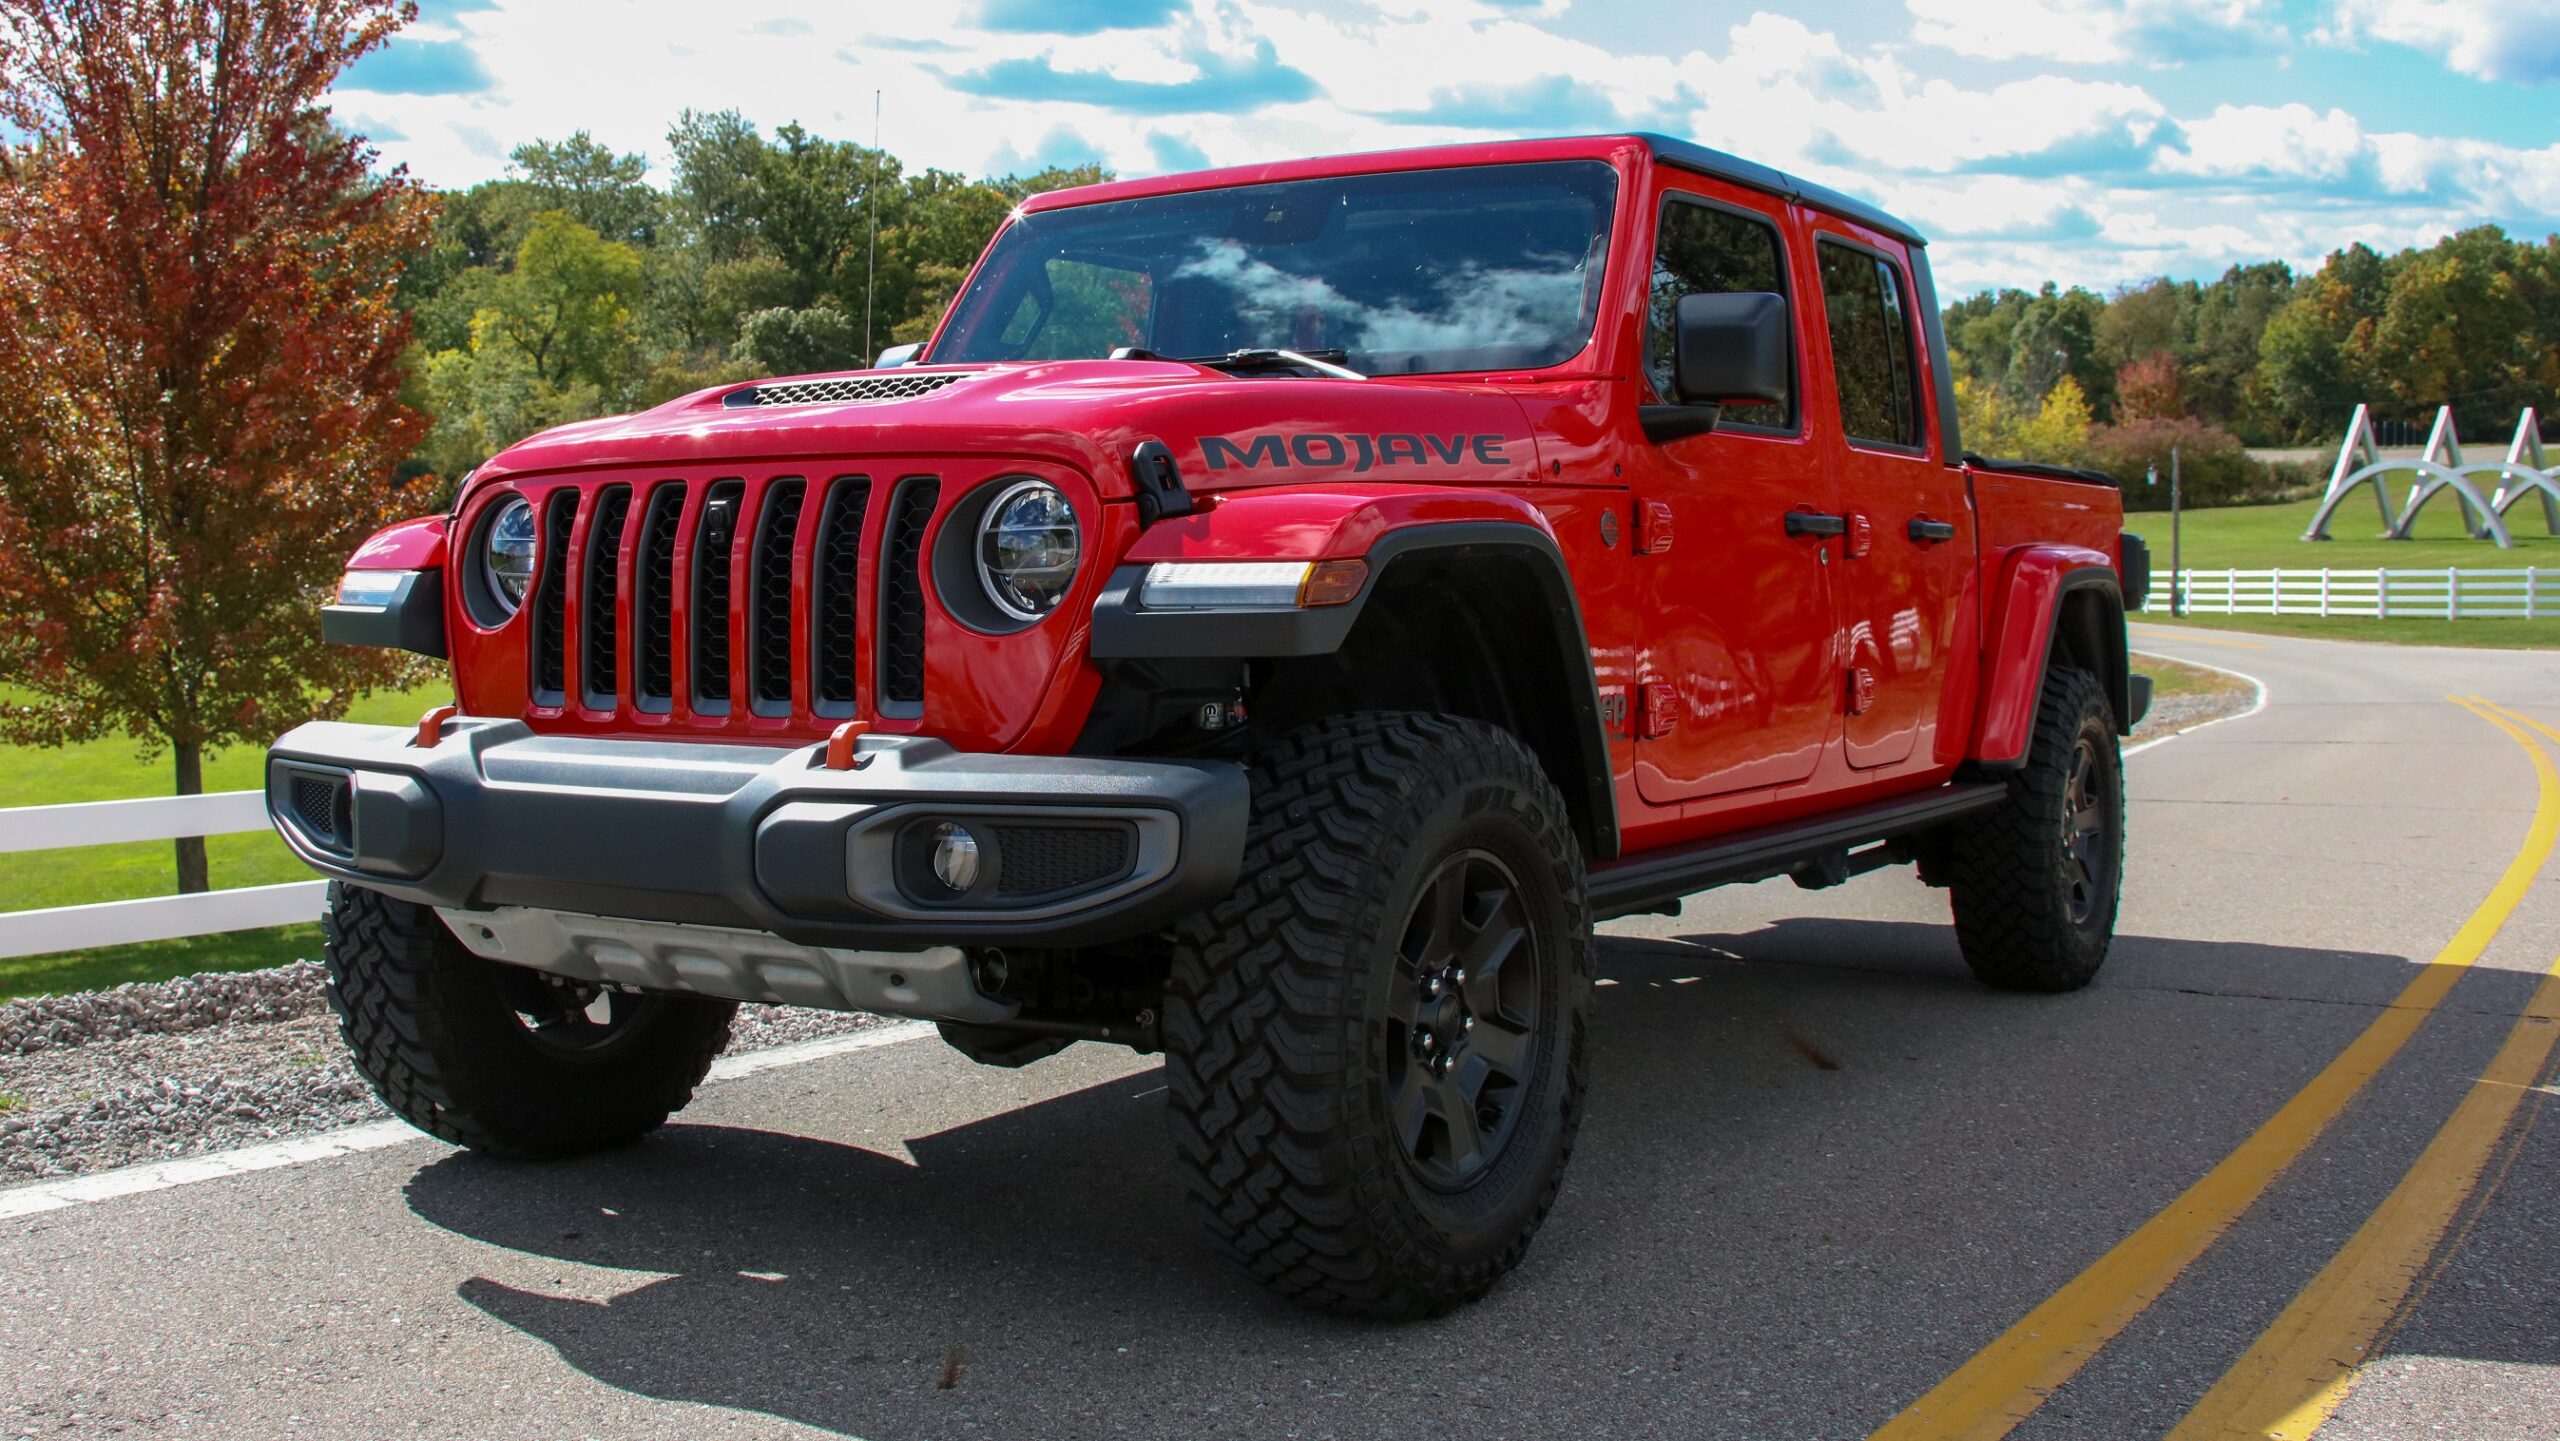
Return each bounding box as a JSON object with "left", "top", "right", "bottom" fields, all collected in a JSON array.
[{"left": 1091, "top": 486, "right": 1618, "bottom": 860}]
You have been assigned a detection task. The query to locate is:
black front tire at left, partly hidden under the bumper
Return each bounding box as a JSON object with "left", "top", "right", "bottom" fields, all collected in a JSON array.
[{"left": 323, "top": 883, "right": 737, "bottom": 1159}]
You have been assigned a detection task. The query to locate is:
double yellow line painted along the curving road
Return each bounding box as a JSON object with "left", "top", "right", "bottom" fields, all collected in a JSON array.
[{"left": 1874, "top": 696, "right": 2560, "bottom": 1441}]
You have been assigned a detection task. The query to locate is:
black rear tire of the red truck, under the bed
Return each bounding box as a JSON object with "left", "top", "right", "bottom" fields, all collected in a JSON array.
[{"left": 1933, "top": 660, "right": 2125, "bottom": 991}]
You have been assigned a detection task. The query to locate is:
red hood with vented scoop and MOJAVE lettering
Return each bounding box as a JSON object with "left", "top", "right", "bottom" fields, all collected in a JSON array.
[{"left": 481, "top": 361, "right": 1539, "bottom": 497}]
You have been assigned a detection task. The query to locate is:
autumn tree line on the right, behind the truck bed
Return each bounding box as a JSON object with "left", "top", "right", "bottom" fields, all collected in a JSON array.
[{"left": 1946, "top": 225, "right": 2560, "bottom": 504}]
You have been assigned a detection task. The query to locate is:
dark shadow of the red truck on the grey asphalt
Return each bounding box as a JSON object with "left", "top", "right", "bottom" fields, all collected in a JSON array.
[{"left": 407, "top": 921, "right": 2555, "bottom": 1441}]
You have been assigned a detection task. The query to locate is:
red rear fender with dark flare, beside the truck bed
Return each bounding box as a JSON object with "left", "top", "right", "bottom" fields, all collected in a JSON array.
[{"left": 1966, "top": 545, "right": 2132, "bottom": 770}]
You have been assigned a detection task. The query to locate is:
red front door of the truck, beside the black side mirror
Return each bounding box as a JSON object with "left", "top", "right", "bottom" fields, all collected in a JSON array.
[{"left": 1628, "top": 189, "right": 1841, "bottom": 804}]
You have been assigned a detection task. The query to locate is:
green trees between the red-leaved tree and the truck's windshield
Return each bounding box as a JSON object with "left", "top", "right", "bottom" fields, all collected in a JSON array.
[{"left": 399, "top": 110, "right": 1103, "bottom": 486}]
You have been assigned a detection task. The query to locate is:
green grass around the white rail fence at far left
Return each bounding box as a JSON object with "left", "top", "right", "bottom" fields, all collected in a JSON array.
[{"left": 0, "top": 681, "right": 451, "bottom": 1001}]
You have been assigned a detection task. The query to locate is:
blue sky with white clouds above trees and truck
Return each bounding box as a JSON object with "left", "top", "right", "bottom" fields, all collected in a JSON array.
[{"left": 335, "top": 0, "right": 2560, "bottom": 292}]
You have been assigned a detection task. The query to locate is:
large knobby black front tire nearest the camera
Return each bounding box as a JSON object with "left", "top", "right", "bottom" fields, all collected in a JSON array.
[{"left": 1165, "top": 714, "right": 1592, "bottom": 1318}]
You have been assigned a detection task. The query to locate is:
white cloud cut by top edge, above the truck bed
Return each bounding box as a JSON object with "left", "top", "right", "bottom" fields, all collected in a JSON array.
[{"left": 1907, "top": 0, "right": 2284, "bottom": 64}]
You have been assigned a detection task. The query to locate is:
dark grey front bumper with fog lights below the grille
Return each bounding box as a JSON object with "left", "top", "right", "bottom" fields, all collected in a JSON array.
[{"left": 266, "top": 719, "right": 1249, "bottom": 950}]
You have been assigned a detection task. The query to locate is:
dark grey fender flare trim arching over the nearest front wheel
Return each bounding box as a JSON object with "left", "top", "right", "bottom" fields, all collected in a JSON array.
[{"left": 1088, "top": 507, "right": 1618, "bottom": 863}]
